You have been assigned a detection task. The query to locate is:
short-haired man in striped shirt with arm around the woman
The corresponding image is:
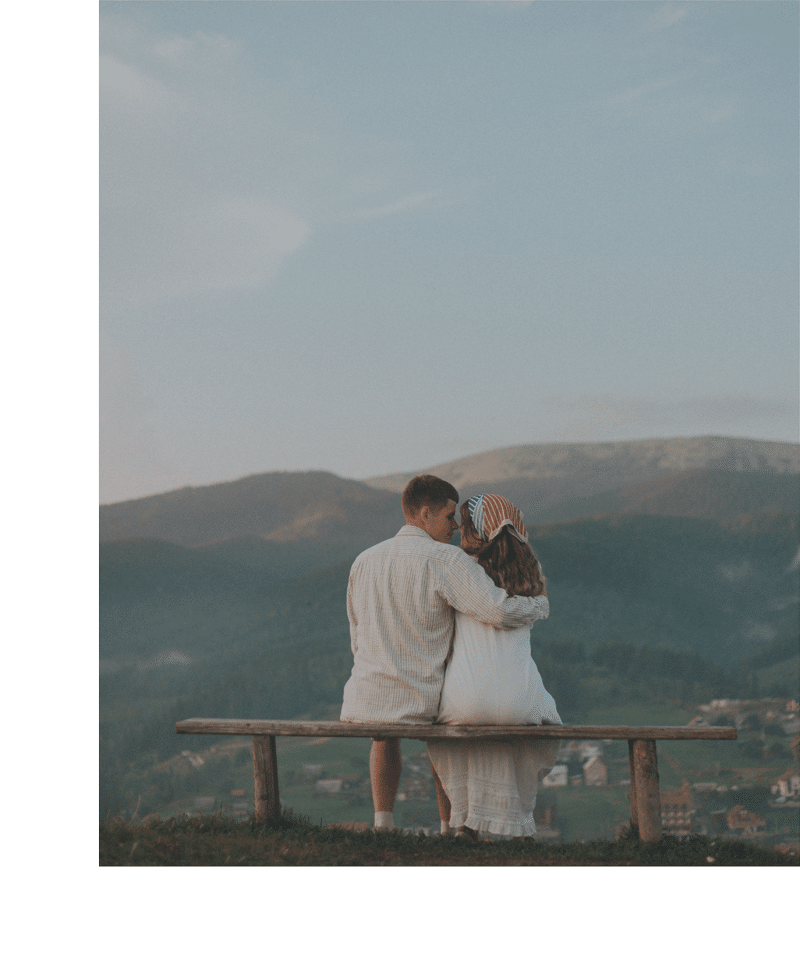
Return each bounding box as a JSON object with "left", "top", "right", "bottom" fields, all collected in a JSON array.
[{"left": 341, "top": 474, "right": 552, "bottom": 833}]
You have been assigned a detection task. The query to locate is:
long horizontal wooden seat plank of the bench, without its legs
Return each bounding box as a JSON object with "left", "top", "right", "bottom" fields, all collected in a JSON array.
[{"left": 175, "top": 717, "right": 736, "bottom": 740}]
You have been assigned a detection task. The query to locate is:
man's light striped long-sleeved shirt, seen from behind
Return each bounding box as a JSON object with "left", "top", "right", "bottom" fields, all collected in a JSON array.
[{"left": 341, "top": 525, "right": 550, "bottom": 723}]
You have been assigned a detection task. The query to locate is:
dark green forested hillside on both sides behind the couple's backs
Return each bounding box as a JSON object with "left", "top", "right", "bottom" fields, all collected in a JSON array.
[{"left": 100, "top": 516, "right": 798, "bottom": 809}]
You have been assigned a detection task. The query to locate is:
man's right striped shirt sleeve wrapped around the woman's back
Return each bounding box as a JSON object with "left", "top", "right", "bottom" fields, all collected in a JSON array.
[{"left": 440, "top": 550, "right": 550, "bottom": 630}]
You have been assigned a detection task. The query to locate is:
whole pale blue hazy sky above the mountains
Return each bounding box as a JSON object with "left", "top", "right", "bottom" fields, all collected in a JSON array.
[{"left": 99, "top": 0, "right": 798, "bottom": 503}]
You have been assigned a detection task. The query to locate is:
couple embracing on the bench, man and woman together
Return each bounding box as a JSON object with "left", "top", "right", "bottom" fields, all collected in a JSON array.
[{"left": 341, "top": 475, "right": 561, "bottom": 838}]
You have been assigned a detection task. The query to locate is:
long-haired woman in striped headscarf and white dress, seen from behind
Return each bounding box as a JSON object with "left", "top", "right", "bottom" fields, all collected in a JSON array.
[{"left": 428, "top": 494, "right": 561, "bottom": 837}]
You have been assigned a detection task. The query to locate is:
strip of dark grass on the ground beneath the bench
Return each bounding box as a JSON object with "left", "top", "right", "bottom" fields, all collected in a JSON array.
[{"left": 99, "top": 809, "right": 797, "bottom": 867}]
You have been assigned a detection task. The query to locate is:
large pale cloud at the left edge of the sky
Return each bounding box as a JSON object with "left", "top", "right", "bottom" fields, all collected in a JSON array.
[{"left": 99, "top": 17, "right": 311, "bottom": 314}]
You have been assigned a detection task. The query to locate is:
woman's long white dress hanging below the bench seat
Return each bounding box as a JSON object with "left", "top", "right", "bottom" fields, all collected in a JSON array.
[{"left": 428, "top": 597, "right": 561, "bottom": 837}]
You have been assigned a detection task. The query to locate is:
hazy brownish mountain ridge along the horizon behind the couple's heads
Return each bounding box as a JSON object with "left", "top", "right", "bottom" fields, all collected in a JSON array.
[{"left": 100, "top": 437, "right": 800, "bottom": 548}]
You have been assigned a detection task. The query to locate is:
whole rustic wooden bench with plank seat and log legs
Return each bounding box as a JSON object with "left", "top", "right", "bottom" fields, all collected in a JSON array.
[{"left": 175, "top": 719, "right": 736, "bottom": 841}]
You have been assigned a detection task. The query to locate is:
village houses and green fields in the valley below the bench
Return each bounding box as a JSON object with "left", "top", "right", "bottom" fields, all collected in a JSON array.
[{"left": 159, "top": 699, "right": 800, "bottom": 856}]
